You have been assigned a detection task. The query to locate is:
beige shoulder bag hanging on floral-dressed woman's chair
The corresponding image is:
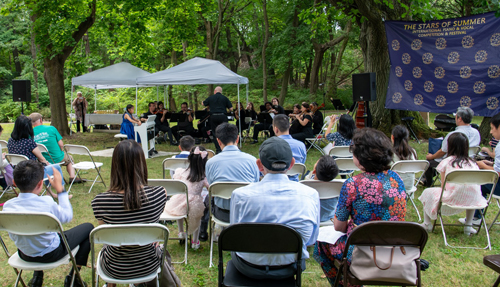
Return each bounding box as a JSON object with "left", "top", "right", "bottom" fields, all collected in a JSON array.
[{"left": 350, "top": 246, "right": 420, "bottom": 285}]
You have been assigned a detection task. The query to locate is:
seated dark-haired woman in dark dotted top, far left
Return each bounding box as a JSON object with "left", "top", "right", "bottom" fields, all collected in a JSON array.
[{"left": 7, "top": 115, "right": 66, "bottom": 198}]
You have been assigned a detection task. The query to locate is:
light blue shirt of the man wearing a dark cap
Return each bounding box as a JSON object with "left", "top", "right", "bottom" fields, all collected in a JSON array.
[{"left": 230, "top": 173, "right": 320, "bottom": 265}]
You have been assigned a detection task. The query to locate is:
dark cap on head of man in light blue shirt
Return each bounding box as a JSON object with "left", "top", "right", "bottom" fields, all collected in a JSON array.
[{"left": 259, "top": 137, "right": 293, "bottom": 171}]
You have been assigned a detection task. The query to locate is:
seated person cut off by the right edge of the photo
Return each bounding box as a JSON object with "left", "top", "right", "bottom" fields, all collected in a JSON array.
[{"left": 466, "top": 113, "right": 500, "bottom": 225}]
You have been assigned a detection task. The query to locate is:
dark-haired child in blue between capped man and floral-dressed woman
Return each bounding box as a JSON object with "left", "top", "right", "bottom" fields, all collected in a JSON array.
[{"left": 312, "top": 155, "right": 339, "bottom": 222}]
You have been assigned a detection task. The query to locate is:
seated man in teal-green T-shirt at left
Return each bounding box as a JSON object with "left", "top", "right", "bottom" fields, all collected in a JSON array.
[{"left": 29, "top": 113, "right": 82, "bottom": 183}]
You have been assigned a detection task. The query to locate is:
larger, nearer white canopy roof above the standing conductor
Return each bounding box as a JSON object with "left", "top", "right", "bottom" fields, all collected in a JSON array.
[{"left": 137, "top": 57, "right": 248, "bottom": 86}]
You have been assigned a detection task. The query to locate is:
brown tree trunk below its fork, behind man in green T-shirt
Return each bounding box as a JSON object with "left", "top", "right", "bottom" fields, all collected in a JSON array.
[{"left": 43, "top": 55, "right": 69, "bottom": 136}]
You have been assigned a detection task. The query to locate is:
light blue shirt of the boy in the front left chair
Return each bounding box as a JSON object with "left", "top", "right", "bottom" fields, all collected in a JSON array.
[{"left": 3, "top": 192, "right": 73, "bottom": 257}]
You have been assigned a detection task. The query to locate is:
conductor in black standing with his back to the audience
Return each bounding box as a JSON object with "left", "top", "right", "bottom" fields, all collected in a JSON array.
[{"left": 203, "top": 87, "right": 233, "bottom": 153}]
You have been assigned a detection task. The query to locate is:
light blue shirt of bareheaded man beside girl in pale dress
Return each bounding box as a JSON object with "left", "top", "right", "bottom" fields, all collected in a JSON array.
[{"left": 205, "top": 145, "right": 259, "bottom": 210}]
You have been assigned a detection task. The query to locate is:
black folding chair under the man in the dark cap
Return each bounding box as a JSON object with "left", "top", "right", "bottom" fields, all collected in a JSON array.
[{"left": 218, "top": 223, "right": 303, "bottom": 286}]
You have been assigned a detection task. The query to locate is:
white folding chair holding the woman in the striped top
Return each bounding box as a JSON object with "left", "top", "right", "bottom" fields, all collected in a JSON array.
[{"left": 90, "top": 223, "right": 169, "bottom": 286}]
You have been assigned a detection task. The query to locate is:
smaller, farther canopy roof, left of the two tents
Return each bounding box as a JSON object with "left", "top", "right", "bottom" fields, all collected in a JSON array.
[{"left": 71, "top": 62, "right": 151, "bottom": 90}]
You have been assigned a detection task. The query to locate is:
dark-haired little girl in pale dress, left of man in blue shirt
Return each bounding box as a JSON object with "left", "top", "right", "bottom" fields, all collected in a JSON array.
[{"left": 165, "top": 146, "right": 209, "bottom": 250}]
